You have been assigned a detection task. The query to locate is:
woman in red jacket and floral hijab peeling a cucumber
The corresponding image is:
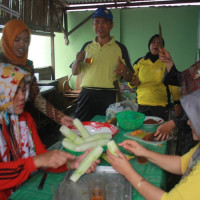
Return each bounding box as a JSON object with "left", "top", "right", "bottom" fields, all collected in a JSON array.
[{"left": 0, "top": 64, "right": 98, "bottom": 200}]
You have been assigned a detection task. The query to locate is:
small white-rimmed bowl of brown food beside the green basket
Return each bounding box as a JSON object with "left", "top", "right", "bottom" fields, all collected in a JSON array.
[{"left": 143, "top": 116, "right": 164, "bottom": 132}]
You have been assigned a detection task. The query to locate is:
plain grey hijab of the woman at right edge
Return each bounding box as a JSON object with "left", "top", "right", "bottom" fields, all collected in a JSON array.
[{"left": 181, "top": 89, "right": 200, "bottom": 177}]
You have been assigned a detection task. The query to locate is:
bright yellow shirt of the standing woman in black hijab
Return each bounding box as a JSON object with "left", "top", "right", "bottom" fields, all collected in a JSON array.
[{"left": 129, "top": 58, "right": 180, "bottom": 106}]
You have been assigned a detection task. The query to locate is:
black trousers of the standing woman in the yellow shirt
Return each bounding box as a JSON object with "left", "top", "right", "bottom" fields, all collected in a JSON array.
[{"left": 138, "top": 105, "right": 169, "bottom": 121}]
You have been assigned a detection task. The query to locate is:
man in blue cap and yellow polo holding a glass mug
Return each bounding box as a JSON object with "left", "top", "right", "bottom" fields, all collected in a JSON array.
[{"left": 72, "top": 7, "right": 133, "bottom": 121}]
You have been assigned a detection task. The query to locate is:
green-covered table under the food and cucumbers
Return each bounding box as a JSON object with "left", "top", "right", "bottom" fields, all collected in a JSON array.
[{"left": 9, "top": 116, "right": 167, "bottom": 200}]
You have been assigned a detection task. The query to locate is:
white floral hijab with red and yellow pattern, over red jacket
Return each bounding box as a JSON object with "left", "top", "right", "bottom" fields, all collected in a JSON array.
[{"left": 0, "top": 64, "right": 34, "bottom": 162}]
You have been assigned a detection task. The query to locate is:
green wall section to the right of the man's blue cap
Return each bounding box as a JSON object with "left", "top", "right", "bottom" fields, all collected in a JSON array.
[{"left": 121, "top": 7, "right": 200, "bottom": 70}]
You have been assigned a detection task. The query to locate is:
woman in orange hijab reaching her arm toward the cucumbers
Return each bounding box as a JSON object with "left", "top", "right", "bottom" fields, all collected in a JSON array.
[{"left": 0, "top": 19, "right": 72, "bottom": 126}]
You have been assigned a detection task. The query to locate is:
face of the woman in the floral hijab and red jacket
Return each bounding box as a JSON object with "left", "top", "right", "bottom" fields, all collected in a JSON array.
[{"left": 13, "top": 79, "right": 26, "bottom": 115}]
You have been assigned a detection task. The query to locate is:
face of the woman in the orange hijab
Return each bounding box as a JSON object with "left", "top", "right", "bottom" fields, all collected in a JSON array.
[{"left": 13, "top": 31, "right": 30, "bottom": 58}]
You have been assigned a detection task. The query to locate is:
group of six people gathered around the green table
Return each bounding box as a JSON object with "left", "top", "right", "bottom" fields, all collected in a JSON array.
[{"left": 0, "top": 7, "right": 200, "bottom": 200}]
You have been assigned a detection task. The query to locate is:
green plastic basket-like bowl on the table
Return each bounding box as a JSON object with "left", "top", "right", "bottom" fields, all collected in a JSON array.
[{"left": 116, "top": 110, "right": 145, "bottom": 131}]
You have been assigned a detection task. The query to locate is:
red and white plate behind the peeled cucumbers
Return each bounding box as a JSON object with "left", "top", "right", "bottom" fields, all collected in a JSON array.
[{"left": 69, "top": 121, "right": 119, "bottom": 136}]
